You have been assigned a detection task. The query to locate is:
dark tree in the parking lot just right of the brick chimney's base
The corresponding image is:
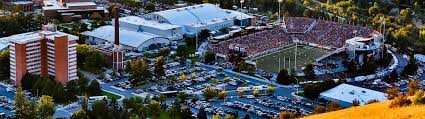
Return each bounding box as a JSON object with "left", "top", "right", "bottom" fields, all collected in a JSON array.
[{"left": 129, "top": 59, "right": 150, "bottom": 86}]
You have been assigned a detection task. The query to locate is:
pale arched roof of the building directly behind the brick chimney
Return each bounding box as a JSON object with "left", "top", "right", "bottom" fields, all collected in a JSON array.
[{"left": 82, "top": 25, "right": 163, "bottom": 48}]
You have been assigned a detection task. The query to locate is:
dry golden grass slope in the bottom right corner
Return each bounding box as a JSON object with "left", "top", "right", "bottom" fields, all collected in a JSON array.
[{"left": 302, "top": 101, "right": 425, "bottom": 119}]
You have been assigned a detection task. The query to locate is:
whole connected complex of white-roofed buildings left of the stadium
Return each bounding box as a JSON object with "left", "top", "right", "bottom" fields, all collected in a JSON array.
[{"left": 82, "top": 3, "right": 256, "bottom": 51}]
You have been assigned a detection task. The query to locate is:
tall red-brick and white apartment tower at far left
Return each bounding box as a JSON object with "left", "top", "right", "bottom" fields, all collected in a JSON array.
[{"left": 2, "top": 25, "right": 78, "bottom": 85}]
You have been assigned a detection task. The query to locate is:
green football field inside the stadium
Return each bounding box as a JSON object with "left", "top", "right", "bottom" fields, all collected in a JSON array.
[{"left": 254, "top": 46, "right": 327, "bottom": 73}]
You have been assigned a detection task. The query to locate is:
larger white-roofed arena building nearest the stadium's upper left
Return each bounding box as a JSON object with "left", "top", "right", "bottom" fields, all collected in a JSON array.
[{"left": 145, "top": 3, "right": 255, "bottom": 34}]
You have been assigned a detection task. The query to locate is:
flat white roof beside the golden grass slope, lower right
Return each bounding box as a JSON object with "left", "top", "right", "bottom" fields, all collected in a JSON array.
[{"left": 320, "top": 84, "right": 387, "bottom": 105}]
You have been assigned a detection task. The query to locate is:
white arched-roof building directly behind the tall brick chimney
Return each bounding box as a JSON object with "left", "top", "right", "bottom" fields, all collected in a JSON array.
[{"left": 83, "top": 25, "right": 170, "bottom": 51}]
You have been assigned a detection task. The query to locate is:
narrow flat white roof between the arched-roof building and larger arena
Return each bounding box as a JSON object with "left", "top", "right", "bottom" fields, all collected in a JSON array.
[{"left": 119, "top": 16, "right": 181, "bottom": 30}]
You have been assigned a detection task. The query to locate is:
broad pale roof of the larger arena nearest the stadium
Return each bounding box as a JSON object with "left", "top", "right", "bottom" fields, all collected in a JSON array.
[{"left": 151, "top": 3, "right": 253, "bottom": 26}]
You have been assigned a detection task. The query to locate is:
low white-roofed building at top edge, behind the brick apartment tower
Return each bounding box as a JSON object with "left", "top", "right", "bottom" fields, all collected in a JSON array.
[{"left": 42, "top": 0, "right": 108, "bottom": 21}]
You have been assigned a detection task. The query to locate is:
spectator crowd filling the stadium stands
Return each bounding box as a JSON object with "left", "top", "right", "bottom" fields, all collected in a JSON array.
[{"left": 210, "top": 17, "right": 374, "bottom": 57}]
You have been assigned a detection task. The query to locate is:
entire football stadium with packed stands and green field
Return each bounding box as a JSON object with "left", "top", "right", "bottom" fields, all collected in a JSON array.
[{"left": 210, "top": 17, "right": 381, "bottom": 73}]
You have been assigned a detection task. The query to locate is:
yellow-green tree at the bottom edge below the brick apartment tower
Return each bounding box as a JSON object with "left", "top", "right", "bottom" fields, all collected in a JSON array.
[{"left": 37, "top": 95, "right": 56, "bottom": 119}]
